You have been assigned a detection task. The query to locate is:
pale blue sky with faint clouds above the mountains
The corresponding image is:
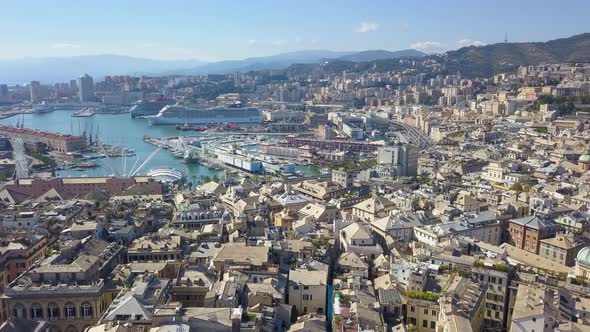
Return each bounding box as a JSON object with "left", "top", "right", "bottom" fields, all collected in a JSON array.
[{"left": 0, "top": 0, "right": 590, "bottom": 61}]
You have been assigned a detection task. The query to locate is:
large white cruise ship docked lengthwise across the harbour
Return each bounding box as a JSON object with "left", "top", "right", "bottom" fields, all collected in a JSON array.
[{"left": 146, "top": 104, "right": 262, "bottom": 125}]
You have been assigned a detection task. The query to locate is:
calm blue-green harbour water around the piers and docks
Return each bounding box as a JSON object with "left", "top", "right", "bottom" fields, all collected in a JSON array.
[{"left": 0, "top": 111, "right": 221, "bottom": 181}]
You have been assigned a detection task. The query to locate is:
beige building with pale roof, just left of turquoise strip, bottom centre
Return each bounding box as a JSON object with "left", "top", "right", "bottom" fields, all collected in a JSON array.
[{"left": 288, "top": 269, "right": 328, "bottom": 315}]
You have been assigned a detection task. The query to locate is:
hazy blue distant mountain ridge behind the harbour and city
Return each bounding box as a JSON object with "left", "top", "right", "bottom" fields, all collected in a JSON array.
[{"left": 0, "top": 49, "right": 428, "bottom": 84}]
